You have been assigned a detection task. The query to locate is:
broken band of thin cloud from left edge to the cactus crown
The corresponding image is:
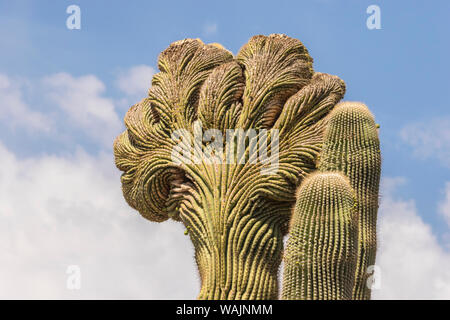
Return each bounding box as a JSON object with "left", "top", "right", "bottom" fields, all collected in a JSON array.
[{"left": 0, "top": 65, "right": 154, "bottom": 149}]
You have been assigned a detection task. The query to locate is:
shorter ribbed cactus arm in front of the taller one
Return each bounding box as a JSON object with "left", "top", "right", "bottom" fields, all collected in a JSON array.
[{"left": 282, "top": 172, "right": 358, "bottom": 300}]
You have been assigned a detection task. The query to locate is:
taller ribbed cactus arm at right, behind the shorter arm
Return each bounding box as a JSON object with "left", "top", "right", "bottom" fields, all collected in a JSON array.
[{"left": 319, "top": 102, "right": 381, "bottom": 300}]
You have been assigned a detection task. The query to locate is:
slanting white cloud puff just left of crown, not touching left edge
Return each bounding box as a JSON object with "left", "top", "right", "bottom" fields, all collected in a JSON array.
[{"left": 43, "top": 73, "right": 121, "bottom": 146}]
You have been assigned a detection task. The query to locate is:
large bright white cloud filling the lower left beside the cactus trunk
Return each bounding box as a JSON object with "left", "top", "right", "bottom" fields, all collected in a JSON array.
[{"left": 0, "top": 143, "right": 199, "bottom": 299}]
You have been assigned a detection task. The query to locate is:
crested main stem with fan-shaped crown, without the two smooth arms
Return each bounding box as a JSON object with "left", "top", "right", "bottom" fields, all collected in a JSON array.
[{"left": 114, "top": 34, "right": 377, "bottom": 299}]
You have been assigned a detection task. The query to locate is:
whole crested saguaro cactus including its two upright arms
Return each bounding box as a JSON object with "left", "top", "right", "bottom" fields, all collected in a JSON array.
[{"left": 114, "top": 34, "right": 380, "bottom": 299}]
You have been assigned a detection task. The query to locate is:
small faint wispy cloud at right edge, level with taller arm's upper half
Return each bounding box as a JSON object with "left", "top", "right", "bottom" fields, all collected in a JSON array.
[{"left": 400, "top": 117, "right": 450, "bottom": 166}]
